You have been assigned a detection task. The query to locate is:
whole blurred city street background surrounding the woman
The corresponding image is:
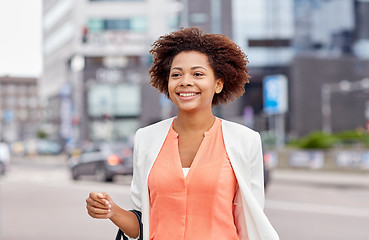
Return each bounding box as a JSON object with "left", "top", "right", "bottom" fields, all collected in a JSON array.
[{"left": 0, "top": 0, "right": 369, "bottom": 240}]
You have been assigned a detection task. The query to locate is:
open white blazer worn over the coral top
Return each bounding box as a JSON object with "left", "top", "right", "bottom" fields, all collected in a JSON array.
[{"left": 131, "top": 118, "right": 279, "bottom": 240}]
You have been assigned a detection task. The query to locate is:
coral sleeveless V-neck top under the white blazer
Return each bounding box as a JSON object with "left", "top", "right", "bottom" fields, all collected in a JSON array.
[{"left": 148, "top": 118, "right": 240, "bottom": 240}]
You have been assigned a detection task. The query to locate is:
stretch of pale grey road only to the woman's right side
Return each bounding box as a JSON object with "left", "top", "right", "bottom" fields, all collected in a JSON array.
[{"left": 265, "top": 170, "right": 369, "bottom": 240}]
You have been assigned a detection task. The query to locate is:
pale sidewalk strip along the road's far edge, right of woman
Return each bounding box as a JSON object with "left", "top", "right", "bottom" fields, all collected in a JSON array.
[{"left": 271, "top": 169, "right": 369, "bottom": 189}]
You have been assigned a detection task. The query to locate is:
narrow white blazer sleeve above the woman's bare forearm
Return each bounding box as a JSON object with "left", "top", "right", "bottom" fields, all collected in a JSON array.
[{"left": 131, "top": 129, "right": 142, "bottom": 211}]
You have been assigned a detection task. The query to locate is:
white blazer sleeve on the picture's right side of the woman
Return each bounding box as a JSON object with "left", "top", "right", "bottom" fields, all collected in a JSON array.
[{"left": 250, "top": 132, "right": 265, "bottom": 209}]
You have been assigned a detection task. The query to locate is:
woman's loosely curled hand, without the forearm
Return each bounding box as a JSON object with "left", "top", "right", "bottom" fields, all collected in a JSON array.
[{"left": 86, "top": 192, "right": 113, "bottom": 219}]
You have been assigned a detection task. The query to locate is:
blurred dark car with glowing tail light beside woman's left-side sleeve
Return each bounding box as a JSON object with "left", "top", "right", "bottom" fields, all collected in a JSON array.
[{"left": 68, "top": 142, "right": 133, "bottom": 182}]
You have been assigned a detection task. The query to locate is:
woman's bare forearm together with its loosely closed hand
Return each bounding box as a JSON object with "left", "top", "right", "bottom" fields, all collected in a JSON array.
[{"left": 86, "top": 192, "right": 139, "bottom": 238}]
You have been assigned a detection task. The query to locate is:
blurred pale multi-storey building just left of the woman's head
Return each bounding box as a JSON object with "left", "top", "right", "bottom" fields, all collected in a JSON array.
[{"left": 40, "top": 0, "right": 182, "bottom": 144}]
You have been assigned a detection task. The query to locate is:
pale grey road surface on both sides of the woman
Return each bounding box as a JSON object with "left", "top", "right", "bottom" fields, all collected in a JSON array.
[{"left": 0, "top": 157, "right": 369, "bottom": 240}]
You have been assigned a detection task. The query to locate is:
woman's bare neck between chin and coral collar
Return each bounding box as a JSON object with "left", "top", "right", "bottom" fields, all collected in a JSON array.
[{"left": 173, "top": 109, "right": 215, "bottom": 134}]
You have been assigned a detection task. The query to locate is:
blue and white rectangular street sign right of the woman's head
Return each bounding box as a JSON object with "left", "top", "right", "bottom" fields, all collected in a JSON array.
[{"left": 263, "top": 75, "right": 288, "bottom": 114}]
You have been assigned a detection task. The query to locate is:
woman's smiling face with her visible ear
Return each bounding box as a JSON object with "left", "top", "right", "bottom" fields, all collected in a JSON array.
[{"left": 168, "top": 51, "right": 223, "bottom": 112}]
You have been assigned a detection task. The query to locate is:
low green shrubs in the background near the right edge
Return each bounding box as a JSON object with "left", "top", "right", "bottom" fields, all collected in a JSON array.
[{"left": 287, "top": 130, "right": 369, "bottom": 149}]
